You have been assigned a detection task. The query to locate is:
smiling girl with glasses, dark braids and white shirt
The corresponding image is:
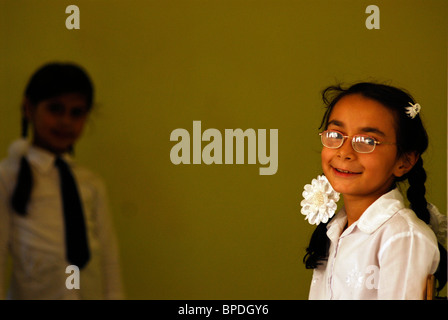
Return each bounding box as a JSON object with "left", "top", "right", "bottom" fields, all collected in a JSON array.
[{"left": 304, "top": 83, "right": 447, "bottom": 299}]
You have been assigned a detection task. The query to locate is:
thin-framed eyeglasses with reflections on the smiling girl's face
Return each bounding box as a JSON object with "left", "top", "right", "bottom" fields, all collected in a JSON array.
[{"left": 319, "top": 130, "right": 395, "bottom": 153}]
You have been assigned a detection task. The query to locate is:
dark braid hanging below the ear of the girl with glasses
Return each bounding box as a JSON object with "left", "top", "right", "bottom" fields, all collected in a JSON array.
[{"left": 407, "top": 157, "right": 430, "bottom": 224}]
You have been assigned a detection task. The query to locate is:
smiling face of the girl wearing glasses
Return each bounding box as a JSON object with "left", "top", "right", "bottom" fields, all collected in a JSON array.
[{"left": 321, "top": 94, "right": 409, "bottom": 203}]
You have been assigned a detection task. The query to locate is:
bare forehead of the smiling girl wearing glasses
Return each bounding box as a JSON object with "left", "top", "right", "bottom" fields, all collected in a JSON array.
[{"left": 328, "top": 94, "right": 396, "bottom": 135}]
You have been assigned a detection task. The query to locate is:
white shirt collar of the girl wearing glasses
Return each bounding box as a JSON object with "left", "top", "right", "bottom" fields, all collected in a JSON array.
[{"left": 327, "top": 188, "right": 404, "bottom": 241}]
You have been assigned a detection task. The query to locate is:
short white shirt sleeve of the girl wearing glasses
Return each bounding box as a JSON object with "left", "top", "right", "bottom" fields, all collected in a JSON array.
[{"left": 378, "top": 231, "right": 440, "bottom": 300}]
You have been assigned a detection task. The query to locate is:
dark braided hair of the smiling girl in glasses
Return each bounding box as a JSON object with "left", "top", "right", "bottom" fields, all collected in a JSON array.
[{"left": 303, "top": 82, "right": 447, "bottom": 291}]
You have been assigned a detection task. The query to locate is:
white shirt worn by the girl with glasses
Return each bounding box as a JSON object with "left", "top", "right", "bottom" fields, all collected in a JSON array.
[{"left": 309, "top": 189, "right": 440, "bottom": 300}]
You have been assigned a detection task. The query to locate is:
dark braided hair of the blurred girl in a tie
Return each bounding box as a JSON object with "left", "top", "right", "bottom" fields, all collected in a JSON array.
[{"left": 11, "top": 63, "right": 94, "bottom": 215}]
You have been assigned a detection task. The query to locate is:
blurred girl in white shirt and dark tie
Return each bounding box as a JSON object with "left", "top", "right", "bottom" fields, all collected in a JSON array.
[{"left": 0, "top": 63, "right": 123, "bottom": 299}]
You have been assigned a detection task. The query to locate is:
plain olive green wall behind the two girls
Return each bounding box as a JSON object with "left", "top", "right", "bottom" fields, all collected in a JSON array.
[{"left": 0, "top": 0, "right": 448, "bottom": 299}]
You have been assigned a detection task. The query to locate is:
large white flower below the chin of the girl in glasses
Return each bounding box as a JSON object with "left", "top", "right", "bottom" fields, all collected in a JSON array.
[{"left": 300, "top": 175, "right": 339, "bottom": 225}]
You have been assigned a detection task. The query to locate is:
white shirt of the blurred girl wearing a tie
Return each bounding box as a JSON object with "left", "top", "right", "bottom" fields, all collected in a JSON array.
[{"left": 0, "top": 140, "right": 123, "bottom": 299}]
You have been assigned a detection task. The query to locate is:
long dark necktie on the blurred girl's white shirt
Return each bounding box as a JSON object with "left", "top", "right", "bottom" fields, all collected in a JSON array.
[{"left": 55, "top": 158, "right": 90, "bottom": 269}]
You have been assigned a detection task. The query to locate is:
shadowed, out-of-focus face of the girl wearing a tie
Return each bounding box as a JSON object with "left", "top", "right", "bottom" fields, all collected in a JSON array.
[{"left": 26, "top": 93, "right": 89, "bottom": 154}]
